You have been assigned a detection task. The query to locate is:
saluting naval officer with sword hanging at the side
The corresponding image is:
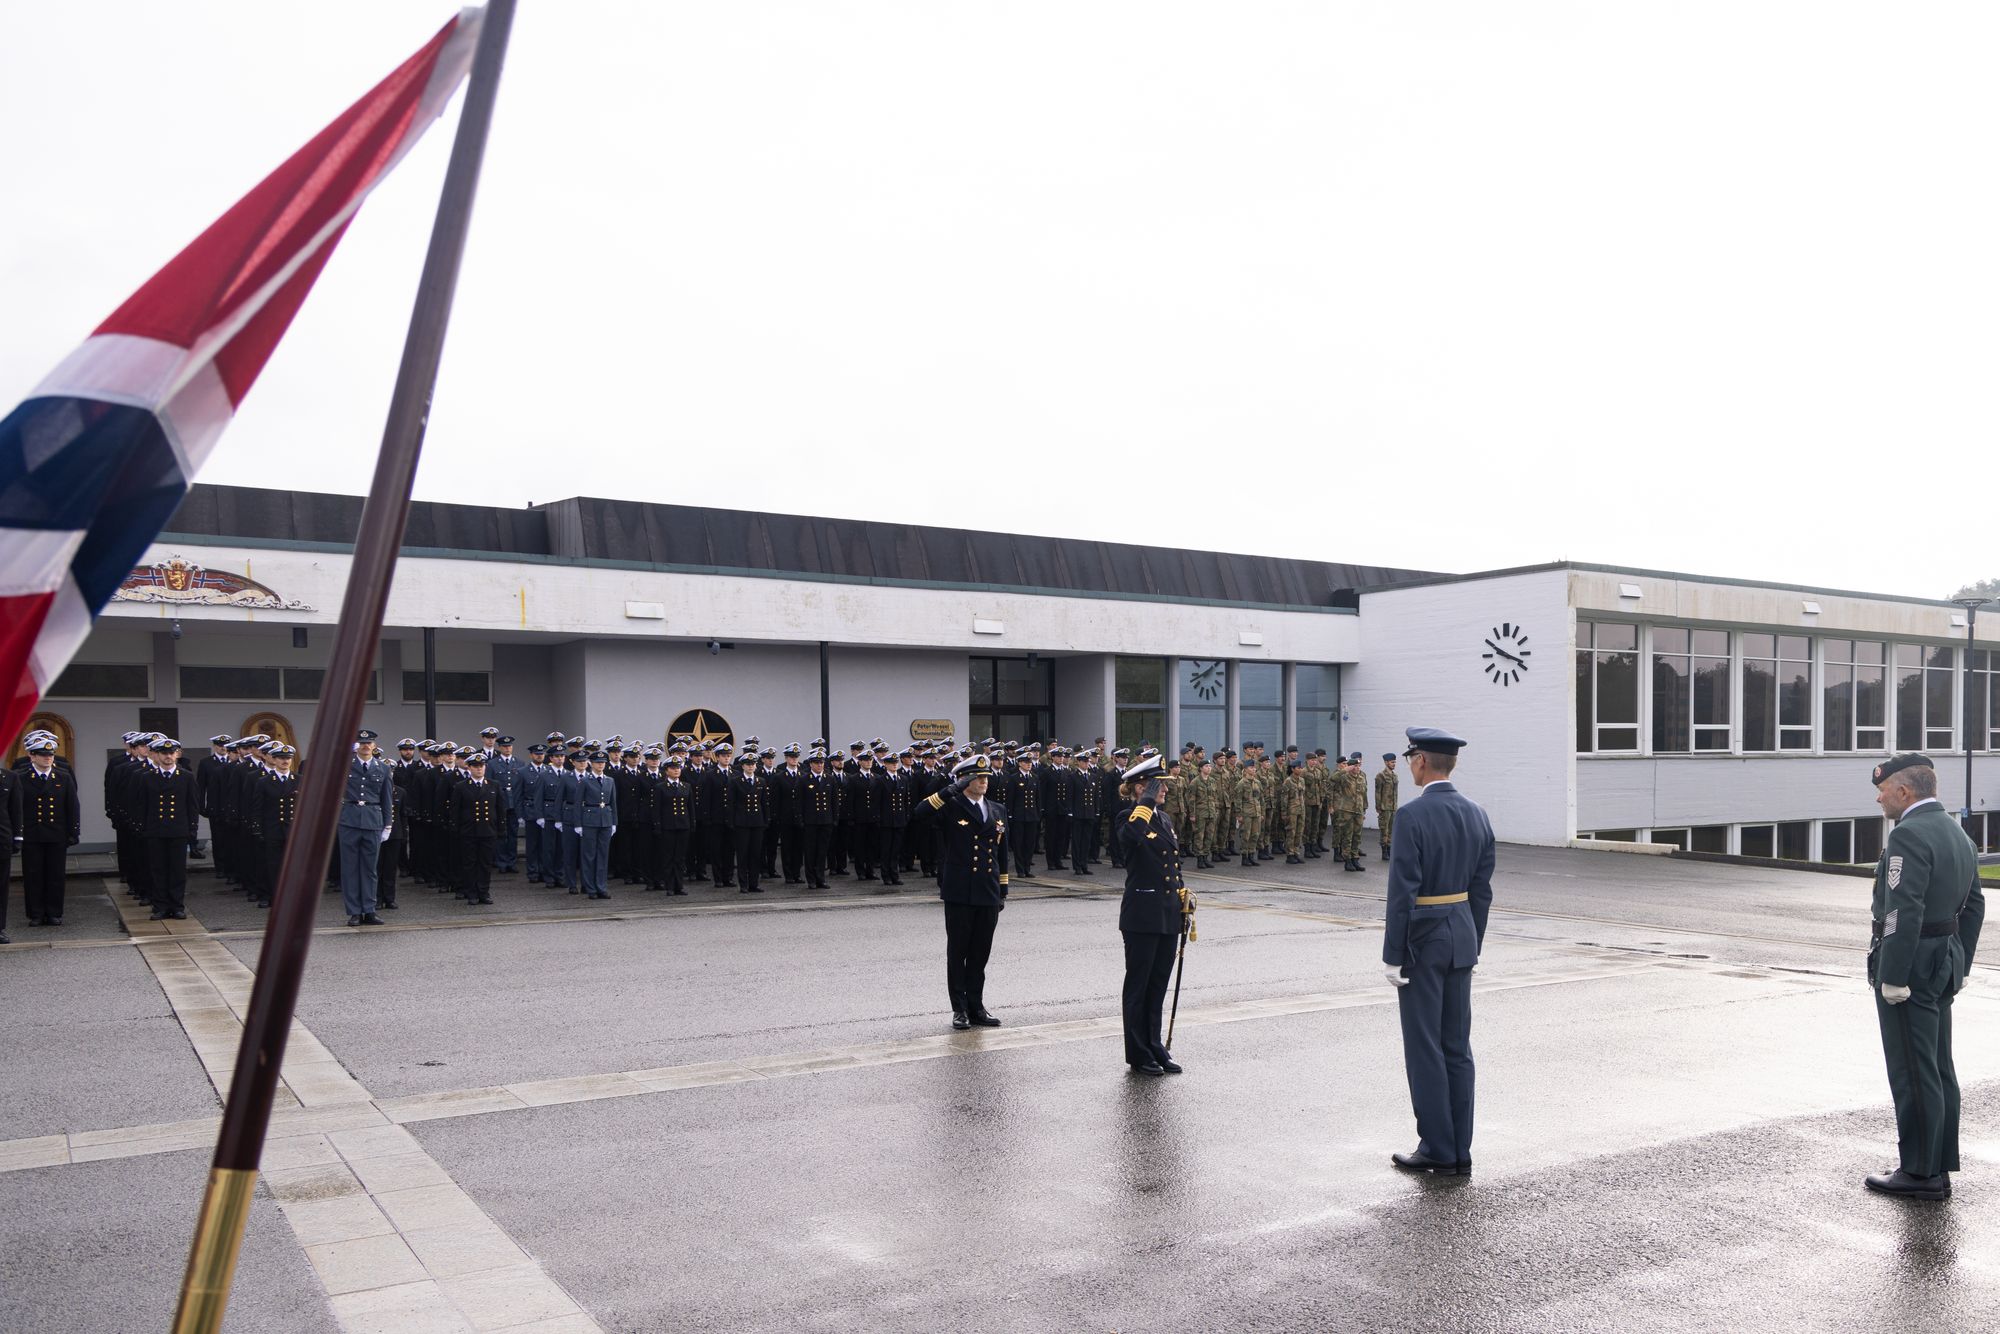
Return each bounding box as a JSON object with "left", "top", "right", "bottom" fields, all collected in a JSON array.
[{"left": 1112, "top": 754, "right": 1190, "bottom": 1074}]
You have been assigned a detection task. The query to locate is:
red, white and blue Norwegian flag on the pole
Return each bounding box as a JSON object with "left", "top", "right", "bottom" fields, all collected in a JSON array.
[{"left": 0, "top": 8, "right": 486, "bottom": 738}]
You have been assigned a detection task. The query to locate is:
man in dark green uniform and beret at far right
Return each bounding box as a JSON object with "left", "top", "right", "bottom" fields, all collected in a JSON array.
[{"left": 1868, "top": 754, "right": 1986, "bottom": 1200}]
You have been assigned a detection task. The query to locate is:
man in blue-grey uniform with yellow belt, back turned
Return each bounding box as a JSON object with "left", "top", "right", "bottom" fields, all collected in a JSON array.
[{"left": 1382, "top": 728, "right": 1494, "bottom": 1176}]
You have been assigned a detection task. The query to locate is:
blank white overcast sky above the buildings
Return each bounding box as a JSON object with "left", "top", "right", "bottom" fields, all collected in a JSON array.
[{"left": 0, "top": 0, "right": 2000, "bottom": 596}]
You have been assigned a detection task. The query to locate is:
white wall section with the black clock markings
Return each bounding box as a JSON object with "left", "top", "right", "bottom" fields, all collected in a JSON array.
[{"left": 1340, "top": 570, "right": 1576, "bottom": 844}]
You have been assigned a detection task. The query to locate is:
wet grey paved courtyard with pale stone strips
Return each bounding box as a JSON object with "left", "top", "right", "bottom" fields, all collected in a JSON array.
[{"left": 0, "top": 848, "right": 2000, "bottom": 1334}]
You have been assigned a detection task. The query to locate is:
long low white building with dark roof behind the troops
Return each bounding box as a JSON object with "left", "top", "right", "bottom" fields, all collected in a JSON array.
[{"left": 19, "top": 486, "right": 2000, "bottom": 862}]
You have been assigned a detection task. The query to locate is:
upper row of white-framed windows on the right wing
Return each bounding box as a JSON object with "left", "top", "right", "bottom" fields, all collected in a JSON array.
[{"left": 1576, "top": 620, "right": 2000, "bottom": 754}]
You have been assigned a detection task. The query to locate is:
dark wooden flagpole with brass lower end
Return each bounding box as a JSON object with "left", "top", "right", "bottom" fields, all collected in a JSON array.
[{"left": 174, "top": 0, "right": 514, "bottom": 1334}]
